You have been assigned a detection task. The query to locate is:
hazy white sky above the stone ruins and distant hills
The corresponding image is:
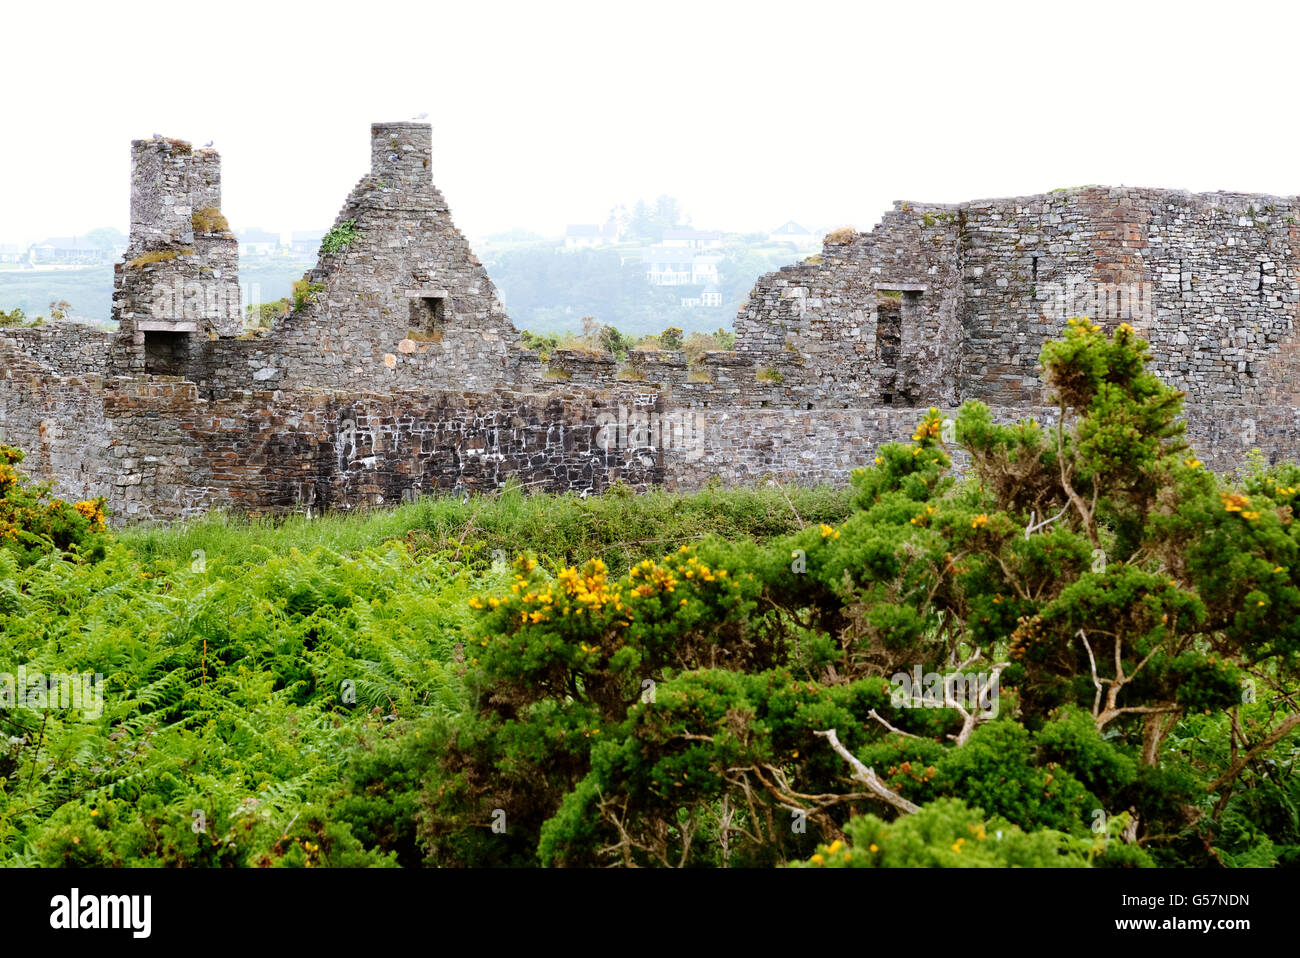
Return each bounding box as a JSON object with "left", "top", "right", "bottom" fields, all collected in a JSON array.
[{"left": 0, "top": 0, "right": 1300, "bottom": 242}]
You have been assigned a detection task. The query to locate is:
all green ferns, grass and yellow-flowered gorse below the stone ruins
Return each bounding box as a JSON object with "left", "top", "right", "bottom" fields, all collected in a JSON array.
[{"left": 0, "top": 321, "right": 1300, "bottom": 867}]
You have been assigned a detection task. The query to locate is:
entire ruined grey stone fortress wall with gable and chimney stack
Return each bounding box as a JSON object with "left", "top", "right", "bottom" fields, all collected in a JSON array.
[{"left": 0, "top": 123, "right": 1300, "bottom": 521}]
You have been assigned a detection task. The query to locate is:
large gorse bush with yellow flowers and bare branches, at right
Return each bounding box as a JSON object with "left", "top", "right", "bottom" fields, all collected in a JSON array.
[{"left": 421, "top": 321, "right": 1300, "bottom": 866}]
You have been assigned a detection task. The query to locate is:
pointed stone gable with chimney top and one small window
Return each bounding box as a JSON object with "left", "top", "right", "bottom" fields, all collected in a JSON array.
[{"left": 191, "top": 123, "right": 520, "bottom": 396}]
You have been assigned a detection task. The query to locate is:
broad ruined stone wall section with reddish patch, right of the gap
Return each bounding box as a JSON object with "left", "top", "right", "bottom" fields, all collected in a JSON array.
[{"left": 736, "top": 187, "right": 1300, "bottom": 407}]
